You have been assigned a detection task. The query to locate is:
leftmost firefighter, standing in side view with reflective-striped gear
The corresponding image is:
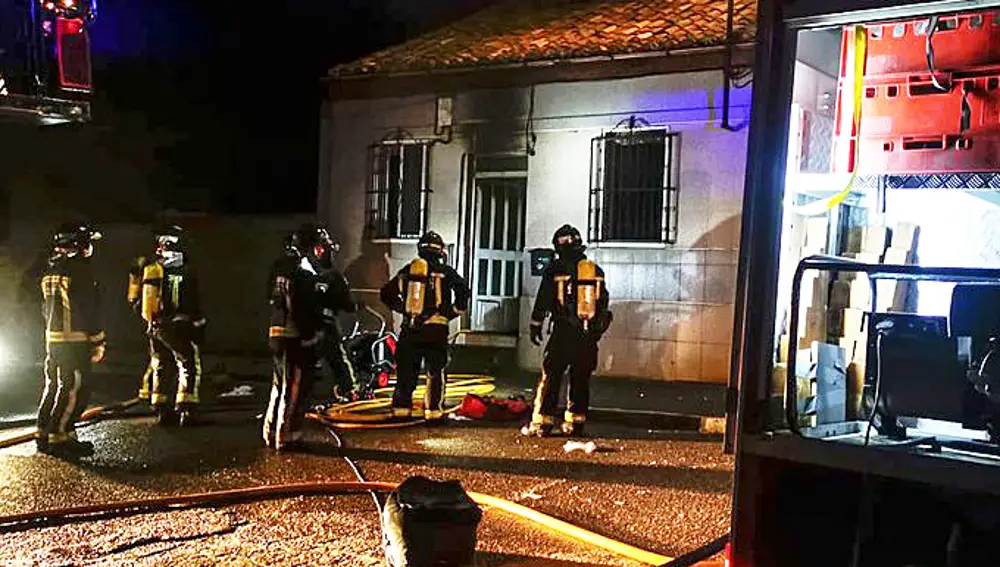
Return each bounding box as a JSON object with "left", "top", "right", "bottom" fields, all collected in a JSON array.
[{"left": 37, "top": 223, "right": 106, "bottom": 457}]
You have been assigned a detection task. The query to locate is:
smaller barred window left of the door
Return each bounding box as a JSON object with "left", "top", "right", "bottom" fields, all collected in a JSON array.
[{"left": 367, "top": 140, "right": 431, "bottom": 238}]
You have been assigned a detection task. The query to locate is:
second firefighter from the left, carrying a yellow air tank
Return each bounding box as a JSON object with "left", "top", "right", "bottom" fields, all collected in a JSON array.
[{"left": 140, "top": 225, "right": 207, "bottom": 426}]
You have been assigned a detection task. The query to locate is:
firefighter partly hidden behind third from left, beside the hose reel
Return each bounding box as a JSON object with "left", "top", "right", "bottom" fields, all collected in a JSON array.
[{"left": 313, "top": 227, "right": 370, "bottom": 402}]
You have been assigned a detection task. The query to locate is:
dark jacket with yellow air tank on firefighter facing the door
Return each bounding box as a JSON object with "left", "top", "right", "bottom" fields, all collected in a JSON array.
[{"left": 381, "top": 258, "right": 470, "bottom": 327}]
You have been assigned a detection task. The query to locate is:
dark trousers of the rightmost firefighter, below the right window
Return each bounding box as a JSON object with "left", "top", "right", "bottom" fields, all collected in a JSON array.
[{"left": 531, "top": 325, "right": 597, "bottom": 425}]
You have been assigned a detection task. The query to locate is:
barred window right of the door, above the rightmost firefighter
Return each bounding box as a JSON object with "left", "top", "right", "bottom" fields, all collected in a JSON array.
[{"left": 588, "top": 127, "right": 680, "bottom": 244}]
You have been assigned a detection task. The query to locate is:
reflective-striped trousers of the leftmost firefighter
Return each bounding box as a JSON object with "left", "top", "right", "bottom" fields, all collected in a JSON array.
[{"left": 38, "top": 342, "right": 94, "bottom": 443}]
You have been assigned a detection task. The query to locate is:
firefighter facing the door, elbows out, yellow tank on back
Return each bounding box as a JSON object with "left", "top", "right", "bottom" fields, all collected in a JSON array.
[{"left": 381, "top": 232, "right": 470, "bottom": 422}]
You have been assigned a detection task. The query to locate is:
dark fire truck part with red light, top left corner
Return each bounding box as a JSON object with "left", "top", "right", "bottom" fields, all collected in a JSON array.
[{"left": 0, "top": 0, "right": 97, "bottom": 125}]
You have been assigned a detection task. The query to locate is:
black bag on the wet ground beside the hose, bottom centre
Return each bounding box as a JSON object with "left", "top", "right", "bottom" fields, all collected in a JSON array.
[{"left": 382, "top": 476, "right": 483, "bottom": 567}]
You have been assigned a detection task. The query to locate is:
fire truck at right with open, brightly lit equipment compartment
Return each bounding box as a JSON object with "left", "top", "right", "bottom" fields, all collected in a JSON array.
[{"left": 728, "top": 0, "right": 1000, "bottom": 567}]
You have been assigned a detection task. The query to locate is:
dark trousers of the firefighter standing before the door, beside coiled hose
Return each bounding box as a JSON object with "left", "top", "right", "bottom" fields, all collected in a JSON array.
[{"left": 392, "top": 324, "right": 448, "bottom": 419}]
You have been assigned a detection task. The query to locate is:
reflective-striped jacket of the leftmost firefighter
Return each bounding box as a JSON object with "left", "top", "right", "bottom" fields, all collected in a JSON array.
[{"left": 41, "top": 258, "right": 105, "bottom": 344}]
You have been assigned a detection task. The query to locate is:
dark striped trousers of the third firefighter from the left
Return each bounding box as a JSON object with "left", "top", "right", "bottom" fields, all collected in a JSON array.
[{"left": 263, "top": 338, "right": 316, "bottom": 449}]
